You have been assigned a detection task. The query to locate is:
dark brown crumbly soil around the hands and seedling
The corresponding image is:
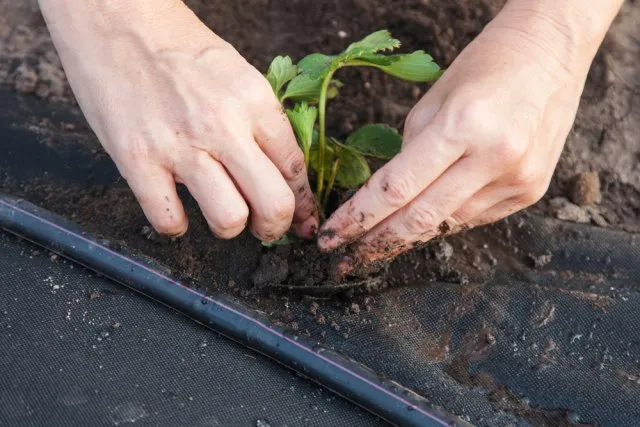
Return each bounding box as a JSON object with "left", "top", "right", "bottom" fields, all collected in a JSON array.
[{"left": 0, "top": 0, "right": 640, "bottom": 425}]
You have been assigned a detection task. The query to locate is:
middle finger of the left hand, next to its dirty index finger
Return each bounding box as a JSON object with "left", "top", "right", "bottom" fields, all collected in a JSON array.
[{"left": 214, "top": 137, "right": 295, "bottom": 242}]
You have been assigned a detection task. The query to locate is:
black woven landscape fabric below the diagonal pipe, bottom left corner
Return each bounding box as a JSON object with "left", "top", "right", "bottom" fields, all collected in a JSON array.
[{"left": 0, "top": 233, "right": 384, "bottom": 427}]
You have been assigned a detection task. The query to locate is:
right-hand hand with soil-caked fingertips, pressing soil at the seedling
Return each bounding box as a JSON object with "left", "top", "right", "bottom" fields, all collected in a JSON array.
[{"left": 319, "top": 4, "right": 590, "bottom": 274}]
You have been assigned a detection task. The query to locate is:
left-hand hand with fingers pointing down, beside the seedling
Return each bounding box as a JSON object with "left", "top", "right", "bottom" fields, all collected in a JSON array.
[{"left": 41, "top": 0, "right": 318, "bottom": 241}]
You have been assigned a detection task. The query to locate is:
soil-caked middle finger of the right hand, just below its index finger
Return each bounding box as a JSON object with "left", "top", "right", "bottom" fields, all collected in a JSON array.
[{"left": 343, "top": 158, "right": 491, "bottom": 276}]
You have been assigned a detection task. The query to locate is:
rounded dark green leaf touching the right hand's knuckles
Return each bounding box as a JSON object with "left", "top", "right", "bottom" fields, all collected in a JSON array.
[{"left": 347, "top": 124, "right": 402, "bottom": 160}]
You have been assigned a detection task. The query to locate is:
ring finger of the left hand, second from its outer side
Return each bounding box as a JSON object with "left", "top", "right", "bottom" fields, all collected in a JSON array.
[{"left": 175, "top": 150, "right": 249, "bottom": 239}]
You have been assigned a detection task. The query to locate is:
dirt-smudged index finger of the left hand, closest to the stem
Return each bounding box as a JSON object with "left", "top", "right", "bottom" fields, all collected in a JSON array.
[{"left": 256, "top": 105, "right": 318, "bottom": 238}]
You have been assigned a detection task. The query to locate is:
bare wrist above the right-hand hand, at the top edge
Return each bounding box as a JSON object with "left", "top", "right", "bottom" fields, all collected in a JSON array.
[{"left": 483, "top": 0, "right": 623, "bottom": 76}]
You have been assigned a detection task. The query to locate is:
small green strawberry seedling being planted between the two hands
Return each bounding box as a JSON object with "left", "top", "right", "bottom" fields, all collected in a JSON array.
[{"left": 266, "top": 30, "right": 442, "bottom": 242}]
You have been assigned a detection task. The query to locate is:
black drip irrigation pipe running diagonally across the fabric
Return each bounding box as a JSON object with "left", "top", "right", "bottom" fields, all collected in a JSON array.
[{"left": 0, "top": 194, "right": 470, "bottom": 427}]
